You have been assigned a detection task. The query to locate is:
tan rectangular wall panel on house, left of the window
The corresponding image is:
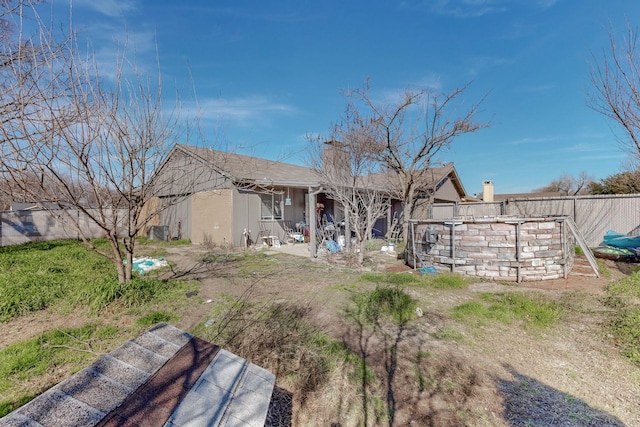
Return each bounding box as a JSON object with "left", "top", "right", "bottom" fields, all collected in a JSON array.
[{"left": 191, "top": 189, "right": 234, "bottom": 245}]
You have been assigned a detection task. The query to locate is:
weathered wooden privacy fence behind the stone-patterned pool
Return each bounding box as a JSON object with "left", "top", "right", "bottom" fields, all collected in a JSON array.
[{"left": 429, "top": 194, "right": 640, "bottom": 247}]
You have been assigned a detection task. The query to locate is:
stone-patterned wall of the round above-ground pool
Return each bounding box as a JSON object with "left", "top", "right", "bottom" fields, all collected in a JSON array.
[{"left": 408, "top": 217, "right": 575, "bottom": 282}]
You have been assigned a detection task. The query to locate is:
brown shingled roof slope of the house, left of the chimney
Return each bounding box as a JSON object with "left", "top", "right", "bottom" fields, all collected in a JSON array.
[{"left": 176, "top": 145, "right": 320, "bottom": 187}]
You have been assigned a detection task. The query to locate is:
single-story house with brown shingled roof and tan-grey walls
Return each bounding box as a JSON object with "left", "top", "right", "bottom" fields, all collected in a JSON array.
[{"left": 154, "top": 145, "right": 465, "bottom": 246}]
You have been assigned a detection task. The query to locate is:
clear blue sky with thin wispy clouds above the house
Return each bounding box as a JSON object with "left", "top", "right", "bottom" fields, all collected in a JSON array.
[{"left": 55, "top": 0, "right": 640, "bottom": 194}]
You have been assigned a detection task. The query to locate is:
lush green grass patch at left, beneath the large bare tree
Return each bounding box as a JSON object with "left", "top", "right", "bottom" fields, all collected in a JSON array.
[{"left": 0, "top": 240, "right": 189, "bottom": 322}]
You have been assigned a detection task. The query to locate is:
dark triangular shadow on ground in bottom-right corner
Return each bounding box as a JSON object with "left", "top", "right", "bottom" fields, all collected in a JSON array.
[{"left": 497, "top": 366, "right": 625, "bottom": 427}]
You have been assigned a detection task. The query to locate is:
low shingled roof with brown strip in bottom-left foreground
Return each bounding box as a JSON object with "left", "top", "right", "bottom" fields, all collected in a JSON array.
[{"left": 0, "top": 323, "right": 275, "bottom": 427}]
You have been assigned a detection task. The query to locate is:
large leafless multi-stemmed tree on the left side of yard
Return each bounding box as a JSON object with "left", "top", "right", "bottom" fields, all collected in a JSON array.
[{"left": 0, "top": 3, "right": 201, "bottom": 282}]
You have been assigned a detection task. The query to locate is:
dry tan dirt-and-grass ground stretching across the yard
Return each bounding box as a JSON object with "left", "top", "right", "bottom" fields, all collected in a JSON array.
[{"left": 0, "top": 247, "right": 640, "bottom": 427}]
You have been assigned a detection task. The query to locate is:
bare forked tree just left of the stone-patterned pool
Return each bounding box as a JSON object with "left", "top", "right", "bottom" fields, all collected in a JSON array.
[{"left": 343, "top": 81, "right": 489, "bottom": 236}]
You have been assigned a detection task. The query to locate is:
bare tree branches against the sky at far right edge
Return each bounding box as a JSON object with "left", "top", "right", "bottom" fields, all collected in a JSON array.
[{"left": 588, "top": 24, "right": 640, "bottom": 159}]
